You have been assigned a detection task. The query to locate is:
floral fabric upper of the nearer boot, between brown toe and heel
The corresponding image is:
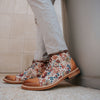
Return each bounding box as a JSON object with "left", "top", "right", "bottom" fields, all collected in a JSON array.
[{"left": 38, "top": 52, "right": 72, "bottom": 86}]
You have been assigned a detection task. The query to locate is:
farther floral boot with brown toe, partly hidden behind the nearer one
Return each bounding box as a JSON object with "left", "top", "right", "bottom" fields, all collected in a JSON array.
[{"left": 3, "top": 60, "right": 47, "bottom": 84}]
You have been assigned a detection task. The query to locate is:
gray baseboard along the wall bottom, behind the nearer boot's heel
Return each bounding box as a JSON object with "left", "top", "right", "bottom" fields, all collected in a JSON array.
[{"left": 66, "top": 75, "right": 100, "bottom": 89}]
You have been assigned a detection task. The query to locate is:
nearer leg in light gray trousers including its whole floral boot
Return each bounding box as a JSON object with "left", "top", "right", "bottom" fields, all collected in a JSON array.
[{"left": 22, "top": 0, "right": 80, "bottom": 90}]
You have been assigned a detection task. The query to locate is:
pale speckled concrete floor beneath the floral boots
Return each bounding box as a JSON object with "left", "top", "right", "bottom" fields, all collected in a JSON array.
[{"left": 0, "top": 74, "right": 100, "bottom": 100}]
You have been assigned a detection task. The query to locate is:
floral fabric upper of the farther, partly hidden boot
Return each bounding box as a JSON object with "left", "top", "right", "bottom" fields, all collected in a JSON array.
[{"left": 16, "top": 62, "right": 46, "bottom": 81}]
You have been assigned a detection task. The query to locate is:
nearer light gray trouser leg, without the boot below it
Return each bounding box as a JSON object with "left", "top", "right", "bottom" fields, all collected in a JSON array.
[{"left": 27, "top": 0, "right": 68, "bottom": 54}]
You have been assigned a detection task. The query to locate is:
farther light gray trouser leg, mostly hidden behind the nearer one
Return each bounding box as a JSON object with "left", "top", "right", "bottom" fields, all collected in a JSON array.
[{"left": 33, "top": 0, "right": 55, "bottom": 60}]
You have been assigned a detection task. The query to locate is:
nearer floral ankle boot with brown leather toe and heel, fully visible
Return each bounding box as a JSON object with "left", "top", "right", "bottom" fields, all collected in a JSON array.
[{"left": 22, "top": 50, "right": 80, "bottom": 90}]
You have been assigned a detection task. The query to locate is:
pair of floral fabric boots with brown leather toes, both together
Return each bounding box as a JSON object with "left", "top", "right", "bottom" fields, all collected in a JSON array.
[{"left": 3, "top": 50, "right": 80, "bottom": 90}]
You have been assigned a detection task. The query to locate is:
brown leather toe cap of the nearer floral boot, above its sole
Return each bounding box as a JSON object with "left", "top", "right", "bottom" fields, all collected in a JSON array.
[{"left": 23, "top": 78, "right": 40, "bottom": 86}]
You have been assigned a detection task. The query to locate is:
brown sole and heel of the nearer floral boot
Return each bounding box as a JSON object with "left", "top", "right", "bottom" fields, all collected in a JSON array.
[{"left": 21, "top": 68, "right": 80, "bottom": 90}]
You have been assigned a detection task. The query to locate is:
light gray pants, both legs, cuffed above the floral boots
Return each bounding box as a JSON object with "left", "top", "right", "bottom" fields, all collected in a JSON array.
[{"left": 27, "top": 0, "right": 68, "bottom": 60}]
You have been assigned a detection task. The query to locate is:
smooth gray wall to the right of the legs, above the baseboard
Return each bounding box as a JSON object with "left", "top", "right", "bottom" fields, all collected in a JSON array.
[{"left": 63, "top": 0, "right": 100, "bottom": 77}]
